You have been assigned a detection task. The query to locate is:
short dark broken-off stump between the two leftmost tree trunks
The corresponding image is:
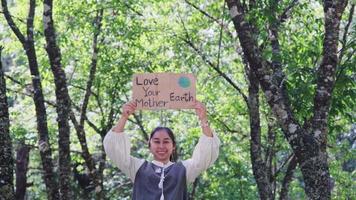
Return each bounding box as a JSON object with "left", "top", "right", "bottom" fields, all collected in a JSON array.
[{"left": 16, "top": 143, "right": 30, "bottom": 200}]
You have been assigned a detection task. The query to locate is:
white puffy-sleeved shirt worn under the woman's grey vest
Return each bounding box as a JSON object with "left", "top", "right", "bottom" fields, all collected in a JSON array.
[{"left": 104, "top": 130, "right": 220, "bottom": 183}]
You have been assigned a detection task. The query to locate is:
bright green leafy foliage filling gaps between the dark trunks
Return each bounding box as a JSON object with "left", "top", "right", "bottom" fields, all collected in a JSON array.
[{"left": 0, "top": 0, "right": 356, "bottom": 200}]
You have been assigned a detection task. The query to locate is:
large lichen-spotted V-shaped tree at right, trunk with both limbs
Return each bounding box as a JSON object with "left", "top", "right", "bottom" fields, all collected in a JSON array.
[{"left": 227, "top": 0, "right": 346, "bottom": 199}]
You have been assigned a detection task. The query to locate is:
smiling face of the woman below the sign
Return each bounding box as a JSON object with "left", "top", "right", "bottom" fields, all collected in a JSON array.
[{"left": 150, "top": 130, "right": 175, "bottom": 164}]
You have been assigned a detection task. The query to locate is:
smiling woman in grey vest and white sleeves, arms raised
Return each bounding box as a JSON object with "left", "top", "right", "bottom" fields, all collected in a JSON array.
[{"left": 104, "top": 101, "right": 220, "bottom": 200}]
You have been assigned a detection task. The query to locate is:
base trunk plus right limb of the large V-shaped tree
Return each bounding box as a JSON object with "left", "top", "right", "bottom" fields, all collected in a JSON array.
[{"left": 298, "top": 0, "right": 347, "bottom": 199}]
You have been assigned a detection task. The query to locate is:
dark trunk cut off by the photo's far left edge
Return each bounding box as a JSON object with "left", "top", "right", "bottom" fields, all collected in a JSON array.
[{"left": 0, "top": 46, "right": 14, "bottom": 200}]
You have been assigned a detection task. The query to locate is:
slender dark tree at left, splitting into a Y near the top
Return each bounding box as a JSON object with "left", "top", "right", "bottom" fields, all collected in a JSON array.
[{"left": 1, "top": 0, "right": 59, "bottom": 200}]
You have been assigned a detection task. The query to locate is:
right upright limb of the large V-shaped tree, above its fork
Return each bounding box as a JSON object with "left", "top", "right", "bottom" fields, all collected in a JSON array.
[{"left": 312, "top": 0, "right": 347, "bottom": 147}]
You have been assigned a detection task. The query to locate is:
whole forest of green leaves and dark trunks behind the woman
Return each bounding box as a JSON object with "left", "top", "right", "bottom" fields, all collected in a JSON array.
[{"left": 0, "top": 0, "right": 356, "bottom": 200}]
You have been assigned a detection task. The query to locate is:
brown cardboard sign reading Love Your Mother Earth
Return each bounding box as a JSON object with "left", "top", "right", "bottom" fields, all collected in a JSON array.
[{"left": 132, "top": 73, "right": 196, "bottom": 110}]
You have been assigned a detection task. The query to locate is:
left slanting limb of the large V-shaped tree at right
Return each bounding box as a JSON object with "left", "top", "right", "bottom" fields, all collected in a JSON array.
[{"left": 227, "top": 0, "right": 301, "bottom": 149}]
